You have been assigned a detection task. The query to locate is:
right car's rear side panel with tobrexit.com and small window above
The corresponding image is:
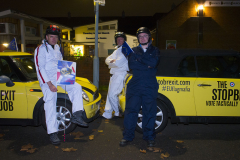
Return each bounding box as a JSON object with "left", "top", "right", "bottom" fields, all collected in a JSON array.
[{"left": 157, "top": 56, "right": 196, "bottom": 116}]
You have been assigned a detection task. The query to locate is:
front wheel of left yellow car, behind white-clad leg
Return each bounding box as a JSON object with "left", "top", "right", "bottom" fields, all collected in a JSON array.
[{"left": 42, "top": 99, "right": 77, "bottom": 134}]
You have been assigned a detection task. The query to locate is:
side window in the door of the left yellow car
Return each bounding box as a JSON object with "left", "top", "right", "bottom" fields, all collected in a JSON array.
[{"left": 0, "top": 58, "right": 20, "bottom": 81}]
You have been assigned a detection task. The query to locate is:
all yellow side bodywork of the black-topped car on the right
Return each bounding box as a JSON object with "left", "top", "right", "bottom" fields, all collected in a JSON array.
[{"left": 121, "top": 77, "right": 240, "bottom": 117}]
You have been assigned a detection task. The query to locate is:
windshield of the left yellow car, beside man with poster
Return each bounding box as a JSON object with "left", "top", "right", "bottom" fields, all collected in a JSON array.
[{"left": 12, "top": 56, "right": 37, "bottom": 80}]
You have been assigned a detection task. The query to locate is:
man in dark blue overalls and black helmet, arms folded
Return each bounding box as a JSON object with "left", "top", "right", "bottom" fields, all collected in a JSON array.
[{"left": 119, "top": 27, "right": 160, "bottom": 147}]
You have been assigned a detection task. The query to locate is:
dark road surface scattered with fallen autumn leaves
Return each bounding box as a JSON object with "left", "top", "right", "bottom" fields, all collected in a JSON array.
[{"left": 0, "top": 117, "right": 240, "bottom": 160}]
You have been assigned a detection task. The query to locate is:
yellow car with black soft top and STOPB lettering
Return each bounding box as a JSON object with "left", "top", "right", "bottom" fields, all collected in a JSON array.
[{"left": 119, "top": 49, "right": 240, "bottom": 132}]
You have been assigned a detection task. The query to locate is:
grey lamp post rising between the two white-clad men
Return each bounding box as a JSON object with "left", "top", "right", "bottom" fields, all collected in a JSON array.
[{"left": 93, "top": 0, "right": 105, "bottom": 88}]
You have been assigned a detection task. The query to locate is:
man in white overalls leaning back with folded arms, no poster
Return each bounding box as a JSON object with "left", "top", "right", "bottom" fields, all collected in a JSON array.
[{"left": 102, "top": 32, "right": 129, "bottom": 119}]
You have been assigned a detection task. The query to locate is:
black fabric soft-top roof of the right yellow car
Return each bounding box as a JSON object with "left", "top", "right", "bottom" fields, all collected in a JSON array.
[{"left": 157, "top": 49, "right": 240, "bottom": 76}]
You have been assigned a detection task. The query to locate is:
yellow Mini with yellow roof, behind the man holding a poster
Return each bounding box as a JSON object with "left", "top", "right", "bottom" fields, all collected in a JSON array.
[{"left": 0, "top": 52, "right": 101, "bottom": 133}]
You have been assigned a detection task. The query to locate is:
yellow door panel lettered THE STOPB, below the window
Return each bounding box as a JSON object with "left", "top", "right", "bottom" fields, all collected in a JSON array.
[{"left": 194, "top": 78, "right": 240, "bottom": 117}]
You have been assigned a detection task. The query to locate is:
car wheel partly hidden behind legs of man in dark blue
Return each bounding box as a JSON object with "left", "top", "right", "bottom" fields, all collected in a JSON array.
[{"left": 136, "top": 100, "right": 168, "bottom": 133}]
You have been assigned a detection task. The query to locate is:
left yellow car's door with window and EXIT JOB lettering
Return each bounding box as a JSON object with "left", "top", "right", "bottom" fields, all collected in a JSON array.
[{"left": 0, "top": 57, "right": 27, "bottom": 119}]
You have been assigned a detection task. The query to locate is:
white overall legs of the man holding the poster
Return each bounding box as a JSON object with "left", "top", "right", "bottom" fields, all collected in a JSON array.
[{"left": 41, "top": 83, "right": 84, "bottom": 134}]
